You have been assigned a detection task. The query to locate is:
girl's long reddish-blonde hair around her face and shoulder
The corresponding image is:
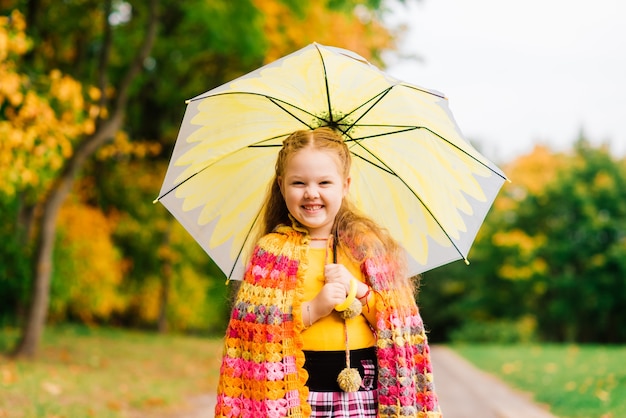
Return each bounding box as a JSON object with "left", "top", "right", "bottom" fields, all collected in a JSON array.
[{"left": 259, "top": 127, "right": 406, "bottom": 290}]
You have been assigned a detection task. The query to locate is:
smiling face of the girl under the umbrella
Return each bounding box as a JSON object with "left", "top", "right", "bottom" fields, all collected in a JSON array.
[{"left": 278, "top": 147, "right": 350, "bottom": 238}]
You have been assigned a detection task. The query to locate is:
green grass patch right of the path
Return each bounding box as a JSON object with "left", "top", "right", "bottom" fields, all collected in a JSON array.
[{"left": 452, "top": 345, "right": 626, "bottom": 418}]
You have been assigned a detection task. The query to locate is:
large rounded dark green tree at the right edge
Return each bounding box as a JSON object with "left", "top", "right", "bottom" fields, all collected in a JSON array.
[{"left": 517, "top": 137, "right": 626, "bottom": 343}]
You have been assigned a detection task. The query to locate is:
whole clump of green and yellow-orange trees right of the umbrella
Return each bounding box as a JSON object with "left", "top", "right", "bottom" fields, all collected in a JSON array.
[{"left": 420, "top": 137, "right": 626, "bottom": 343}]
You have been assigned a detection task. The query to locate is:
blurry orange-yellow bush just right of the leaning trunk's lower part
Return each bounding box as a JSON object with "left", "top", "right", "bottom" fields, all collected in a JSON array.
[{"left": 52, "top": 203, "right": 124, "bottom": 323}]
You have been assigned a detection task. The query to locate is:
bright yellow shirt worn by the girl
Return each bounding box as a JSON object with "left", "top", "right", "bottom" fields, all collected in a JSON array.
[{"left": 302, "top": 248, "right": 376, "bottom": 351}]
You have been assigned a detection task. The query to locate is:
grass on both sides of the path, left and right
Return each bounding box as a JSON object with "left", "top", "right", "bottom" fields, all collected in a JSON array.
[{"left": 0, "top": 326, "right": 626, "bottom": 418}]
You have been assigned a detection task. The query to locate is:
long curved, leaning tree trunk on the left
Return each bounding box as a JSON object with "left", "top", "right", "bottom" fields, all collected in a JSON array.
[{"left": 13, "top": 0, "right": 158, "bottom": 357}]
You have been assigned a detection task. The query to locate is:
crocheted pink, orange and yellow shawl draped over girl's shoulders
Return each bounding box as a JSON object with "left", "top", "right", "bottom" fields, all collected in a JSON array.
[{"left": 215, "top": 226, "right": 441, "bottom": 418}]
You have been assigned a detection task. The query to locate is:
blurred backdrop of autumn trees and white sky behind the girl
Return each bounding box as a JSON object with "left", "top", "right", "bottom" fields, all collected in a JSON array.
[{"left": 0, "top": 0, "right": 626, "bottom": 414}]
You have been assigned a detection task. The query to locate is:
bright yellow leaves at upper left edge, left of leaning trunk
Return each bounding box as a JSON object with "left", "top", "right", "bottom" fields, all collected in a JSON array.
[{"left": 0, "top": 11, "right": 97, "bottom": 196}]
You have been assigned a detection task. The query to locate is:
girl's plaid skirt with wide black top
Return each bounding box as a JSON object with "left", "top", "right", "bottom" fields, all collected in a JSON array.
[{"left": 304, "top": 347, "right": 378, "bottom": 418}]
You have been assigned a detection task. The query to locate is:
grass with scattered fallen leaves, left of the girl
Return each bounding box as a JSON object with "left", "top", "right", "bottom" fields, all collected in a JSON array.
[{"left": 0, "top": 327, "right": 221, "bottom": 418}]
